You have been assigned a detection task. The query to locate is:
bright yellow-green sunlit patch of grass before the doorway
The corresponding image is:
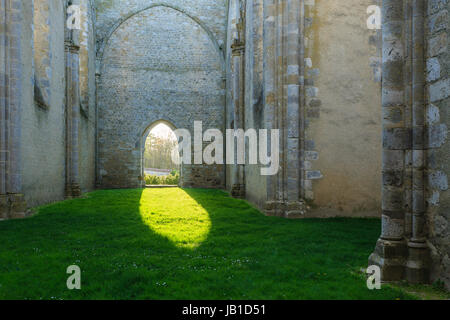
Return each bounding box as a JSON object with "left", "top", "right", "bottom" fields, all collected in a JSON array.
[{"left": 139, "top": 188, "right": 211, "bottom": 249}]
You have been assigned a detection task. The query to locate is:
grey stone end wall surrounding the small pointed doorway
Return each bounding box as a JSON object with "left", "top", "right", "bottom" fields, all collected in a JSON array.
[{"left": 97, "top": 1, "right": 225, "bottom": 187}]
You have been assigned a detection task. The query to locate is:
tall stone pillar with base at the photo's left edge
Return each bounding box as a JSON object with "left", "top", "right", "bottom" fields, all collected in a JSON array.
[{"left": 0, "top": 0, "right": 27, "bottom": 219}]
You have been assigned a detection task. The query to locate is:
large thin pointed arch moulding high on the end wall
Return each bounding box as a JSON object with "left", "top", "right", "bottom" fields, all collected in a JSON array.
[{"left": 97, "top": 2, "right": 225, "bottom": 72}]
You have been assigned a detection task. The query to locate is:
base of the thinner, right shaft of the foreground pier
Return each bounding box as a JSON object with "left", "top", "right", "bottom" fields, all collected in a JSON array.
[{"left": 406, "top": 241, "right": 431, "bottom": 283}]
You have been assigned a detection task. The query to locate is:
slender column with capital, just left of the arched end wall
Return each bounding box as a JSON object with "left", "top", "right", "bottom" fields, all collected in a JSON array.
[{"left": 65, "top": 1, "right": 81, "bottom": 198}]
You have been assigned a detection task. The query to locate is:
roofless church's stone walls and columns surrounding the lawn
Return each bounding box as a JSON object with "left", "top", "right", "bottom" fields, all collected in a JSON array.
[{"left": 0, "top": 0, "right": 450, "bottom": 297}]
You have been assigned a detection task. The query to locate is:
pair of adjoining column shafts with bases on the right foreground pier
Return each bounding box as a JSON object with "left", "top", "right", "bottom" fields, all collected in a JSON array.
[{"left": 369, "top": 0, "right": 428, "bottom": 282}]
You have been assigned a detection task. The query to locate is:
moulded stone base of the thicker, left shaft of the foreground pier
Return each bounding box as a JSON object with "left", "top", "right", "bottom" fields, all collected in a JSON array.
[{"left": 369, "top": 238, "right": 407, "bottom": 282}]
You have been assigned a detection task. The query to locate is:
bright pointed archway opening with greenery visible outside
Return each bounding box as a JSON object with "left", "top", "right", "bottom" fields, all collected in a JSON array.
[{"left": 142, "top": 121, "right": 181, "bottom": 186}]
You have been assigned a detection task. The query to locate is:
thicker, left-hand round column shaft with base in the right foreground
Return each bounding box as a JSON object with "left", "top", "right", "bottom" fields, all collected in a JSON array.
[{"left": 369, "top": 0, "right": 411, "bottom": 281}]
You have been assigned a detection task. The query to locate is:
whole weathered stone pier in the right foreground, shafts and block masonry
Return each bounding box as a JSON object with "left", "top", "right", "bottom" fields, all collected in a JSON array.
[{"left": 369, "top": 0, "right": 449, "bottom": 286}]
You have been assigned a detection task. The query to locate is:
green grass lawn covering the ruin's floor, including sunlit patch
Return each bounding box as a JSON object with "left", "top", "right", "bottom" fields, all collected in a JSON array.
[{"left": 0, "top": 188, "right": 412, "bottom": 299}]
